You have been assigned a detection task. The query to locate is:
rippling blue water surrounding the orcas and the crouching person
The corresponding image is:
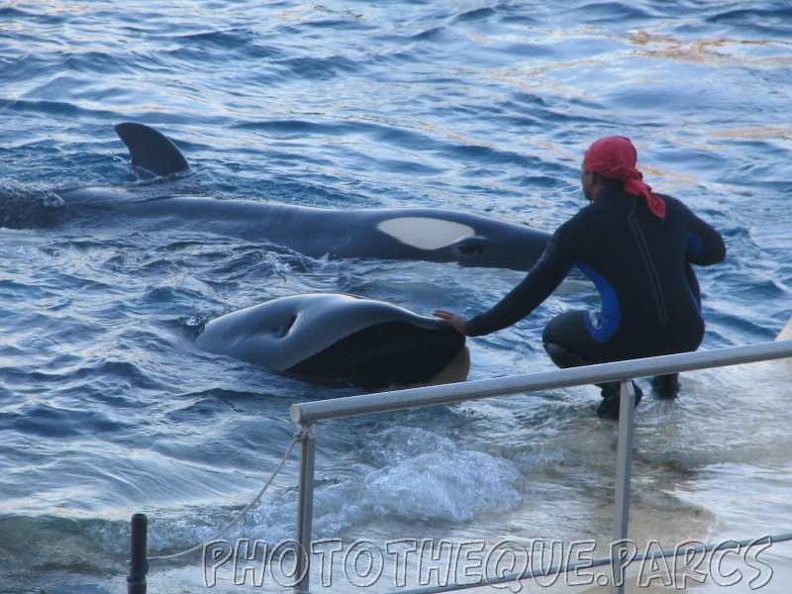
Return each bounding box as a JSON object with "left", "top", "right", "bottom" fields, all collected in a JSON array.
[{"left": 0, "top": 0, "right": 792, "bottom": 594}]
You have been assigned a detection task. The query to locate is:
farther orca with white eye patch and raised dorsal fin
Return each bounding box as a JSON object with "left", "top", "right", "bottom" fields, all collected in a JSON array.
[{"left": 55, "top": 123, "right": 549, "bottom": 270}]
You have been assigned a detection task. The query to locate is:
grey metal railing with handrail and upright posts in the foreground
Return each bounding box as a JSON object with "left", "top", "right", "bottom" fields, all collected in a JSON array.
[{"left": 291, "top": 340, "right": 792, "bottom": 594}]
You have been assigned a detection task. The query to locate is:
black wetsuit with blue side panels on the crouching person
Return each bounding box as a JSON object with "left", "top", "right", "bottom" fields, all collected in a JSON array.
[{"left": 465, "top": 188, "right": 726, "bottom": 367}]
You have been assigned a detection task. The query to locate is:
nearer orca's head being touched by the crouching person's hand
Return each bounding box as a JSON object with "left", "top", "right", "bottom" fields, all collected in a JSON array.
[{"left": 196, "top": 293, "right": 469, "bottom": 389}]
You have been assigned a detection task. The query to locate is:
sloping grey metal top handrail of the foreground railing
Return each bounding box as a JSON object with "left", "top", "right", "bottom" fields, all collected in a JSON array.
[{"left": 290, "top": 340, "right": 792, "bottom": 424}]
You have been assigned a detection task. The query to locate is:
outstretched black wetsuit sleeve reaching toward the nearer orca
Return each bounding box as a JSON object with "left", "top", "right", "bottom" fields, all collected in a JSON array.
[{"left": 465, "top": 227, "right": 571, "bottom": 336}]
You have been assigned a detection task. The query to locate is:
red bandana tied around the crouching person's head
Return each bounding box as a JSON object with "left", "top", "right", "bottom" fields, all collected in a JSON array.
[{"left": 583, "top": 136, "right": 665, "bottom": 219}]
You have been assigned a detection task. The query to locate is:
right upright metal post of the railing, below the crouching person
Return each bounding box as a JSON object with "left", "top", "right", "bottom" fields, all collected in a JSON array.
[{"left": 611, "top": 380, "right": 636, "bottom": 594}]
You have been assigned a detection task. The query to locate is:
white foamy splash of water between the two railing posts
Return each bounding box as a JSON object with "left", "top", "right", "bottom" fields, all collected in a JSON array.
[{"left": 315, "top": 427, "right": 524, "bottom": 535}]
